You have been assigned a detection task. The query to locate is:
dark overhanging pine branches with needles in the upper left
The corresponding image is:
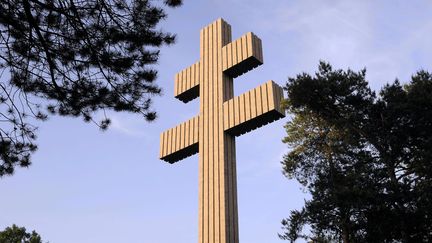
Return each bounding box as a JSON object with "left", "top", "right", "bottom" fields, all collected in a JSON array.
[{"left": 0, "top": 0, "right": 182, "bottom": 177}]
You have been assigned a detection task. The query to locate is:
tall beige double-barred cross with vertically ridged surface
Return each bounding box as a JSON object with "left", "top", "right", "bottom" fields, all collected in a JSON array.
[{"left": 160, "top": 19, "right": 285, "bottom": 243}]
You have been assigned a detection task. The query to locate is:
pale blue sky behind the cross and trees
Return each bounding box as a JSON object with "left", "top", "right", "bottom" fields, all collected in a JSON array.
[{"left": 0, "top": 0, "right": 432, "bottom": 243}]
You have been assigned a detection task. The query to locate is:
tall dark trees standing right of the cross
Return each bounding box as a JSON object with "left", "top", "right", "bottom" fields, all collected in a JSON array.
[{"left": 280, "top": 62, "right": 432, "bottom": 242}]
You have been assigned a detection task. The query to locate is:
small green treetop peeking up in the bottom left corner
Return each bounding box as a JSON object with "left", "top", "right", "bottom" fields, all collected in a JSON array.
[{"left": 0, "top": 224, "right": 42, "bottom": 243}]
